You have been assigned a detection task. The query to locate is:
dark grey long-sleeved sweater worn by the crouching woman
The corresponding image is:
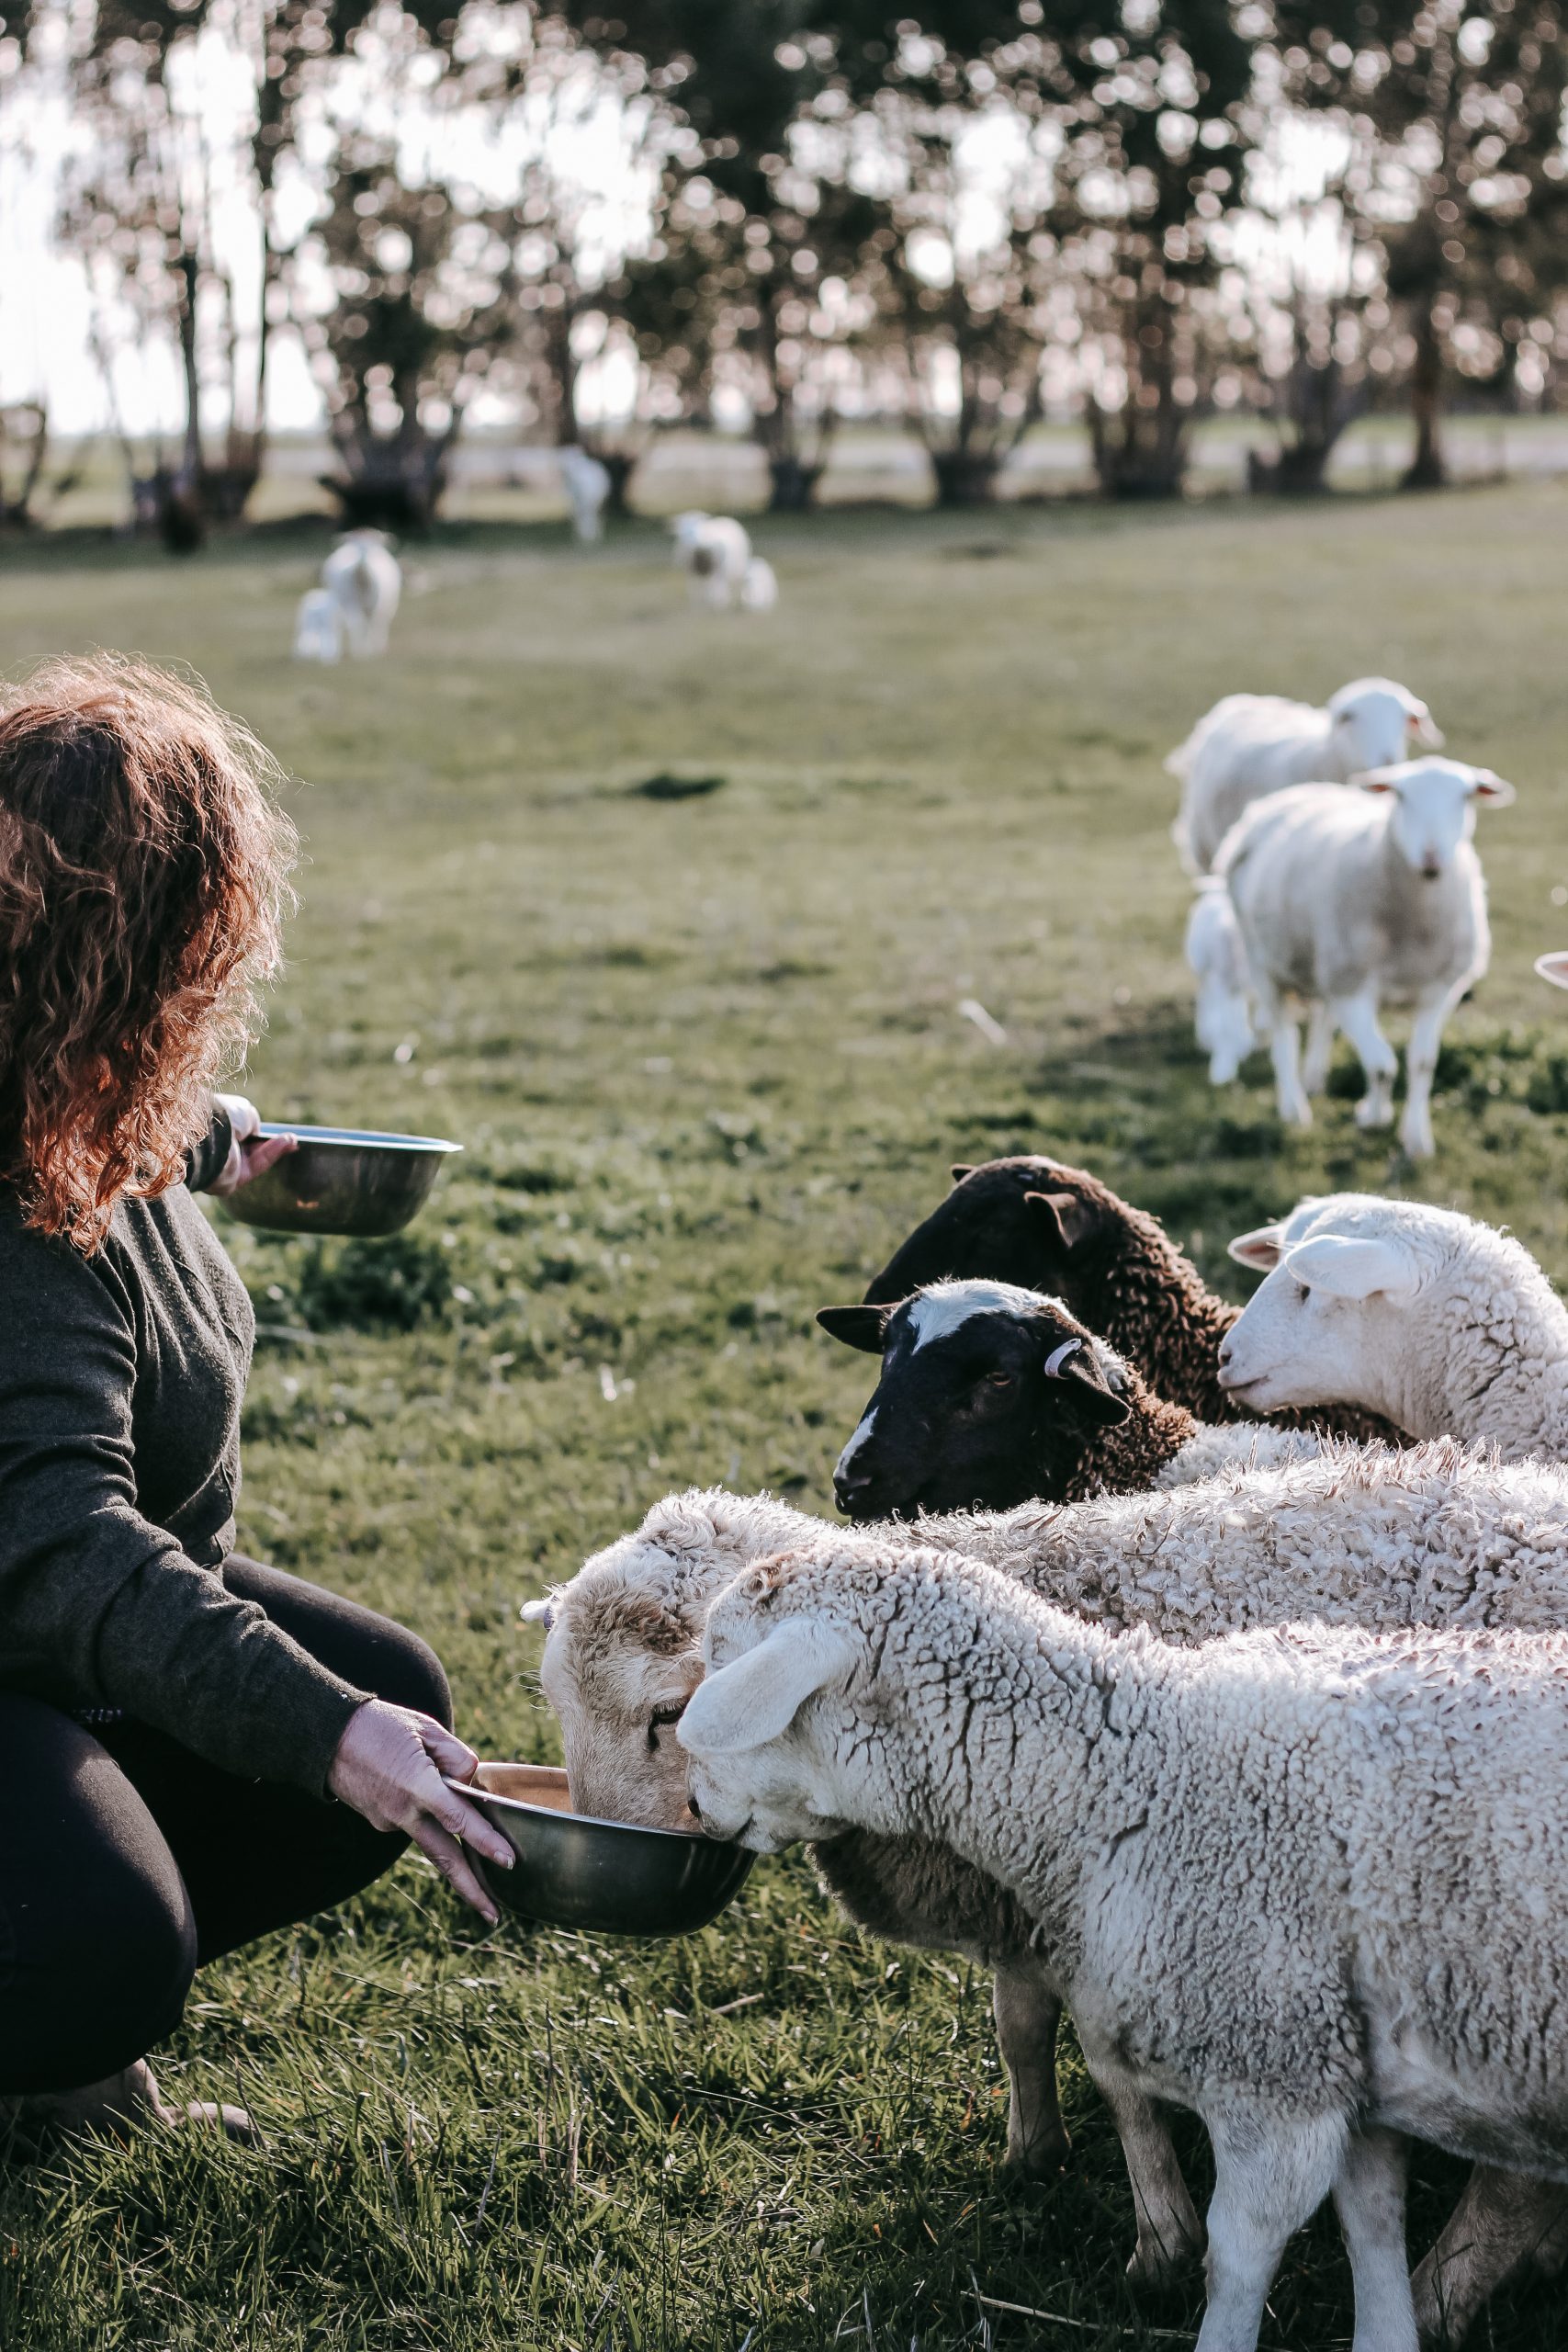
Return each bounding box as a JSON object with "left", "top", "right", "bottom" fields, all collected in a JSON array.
[{"left": 0, "top": 1113, "right": 367, "bottom": 1794}]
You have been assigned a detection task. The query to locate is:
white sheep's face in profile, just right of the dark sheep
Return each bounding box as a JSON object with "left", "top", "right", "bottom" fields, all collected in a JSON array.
[{"left": 1220, "top": 1202, "right": 1434, "bottom": 1420}]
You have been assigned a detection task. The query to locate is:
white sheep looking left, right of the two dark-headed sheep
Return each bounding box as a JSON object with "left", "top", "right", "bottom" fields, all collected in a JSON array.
[{"left": 1220, "top": 1193, "right": 1568, "bottom": 1461}]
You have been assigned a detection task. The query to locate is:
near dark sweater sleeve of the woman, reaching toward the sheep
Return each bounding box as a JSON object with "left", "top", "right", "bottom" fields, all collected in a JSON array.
[{"left": 0, "top": 1244, "right": 369, "bottom": 1794}]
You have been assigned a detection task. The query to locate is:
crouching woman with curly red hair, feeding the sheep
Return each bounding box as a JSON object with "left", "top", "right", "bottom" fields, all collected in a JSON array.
[{"left": 0, "top": 656, "right": 510, "bottom": 2129}]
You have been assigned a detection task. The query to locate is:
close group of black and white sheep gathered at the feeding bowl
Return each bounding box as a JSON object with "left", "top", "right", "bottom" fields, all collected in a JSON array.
[{"left": 525, "top": 1158, "right": 1568, "bottom": 2352}]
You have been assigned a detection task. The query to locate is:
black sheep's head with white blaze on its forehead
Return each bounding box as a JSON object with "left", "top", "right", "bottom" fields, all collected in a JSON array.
[{"left": 818, "top": 1282, "right": 1128, "bottom": 1520}]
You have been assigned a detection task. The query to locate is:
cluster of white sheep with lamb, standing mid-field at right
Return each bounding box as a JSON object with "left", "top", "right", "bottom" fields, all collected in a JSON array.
[{"left": 1166, "top": 677, "right": 1514, "bottom": 1159}]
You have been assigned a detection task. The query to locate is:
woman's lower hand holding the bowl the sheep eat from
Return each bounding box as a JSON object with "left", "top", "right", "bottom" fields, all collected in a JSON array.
[{"left": 327, "top": 1698, "right": 514, "bottom": 1927}]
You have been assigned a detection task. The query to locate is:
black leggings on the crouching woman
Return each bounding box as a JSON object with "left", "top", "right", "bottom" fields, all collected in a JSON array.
[{"left": 0, "top": 1553, "right": 451, "bottom": 2093}]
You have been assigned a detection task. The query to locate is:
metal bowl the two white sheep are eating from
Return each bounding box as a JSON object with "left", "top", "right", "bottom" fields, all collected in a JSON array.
[{"left": 449, "top": 1764, "right": 757, "bottom": 1936}]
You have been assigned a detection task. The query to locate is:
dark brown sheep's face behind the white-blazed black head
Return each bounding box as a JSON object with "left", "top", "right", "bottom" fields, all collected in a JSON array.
[{"left": 865, "top": 1155, "right": 1117, "bottom": 1315}]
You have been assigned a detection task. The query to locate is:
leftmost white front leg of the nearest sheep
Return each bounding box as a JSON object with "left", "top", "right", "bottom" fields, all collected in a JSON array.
[{"left": 1194, "top": 2108, "right": 1344, "bottom": 2352}]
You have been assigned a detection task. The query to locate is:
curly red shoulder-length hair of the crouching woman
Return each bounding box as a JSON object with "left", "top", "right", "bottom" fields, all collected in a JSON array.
[{"left": 0, "top": 654, "right": 296, "bottom": 1251}]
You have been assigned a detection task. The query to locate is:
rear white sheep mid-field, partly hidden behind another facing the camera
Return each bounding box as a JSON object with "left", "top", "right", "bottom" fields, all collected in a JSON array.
[{"left": 1166, "top": 677, "right": 1443, "bottom": 875}]
